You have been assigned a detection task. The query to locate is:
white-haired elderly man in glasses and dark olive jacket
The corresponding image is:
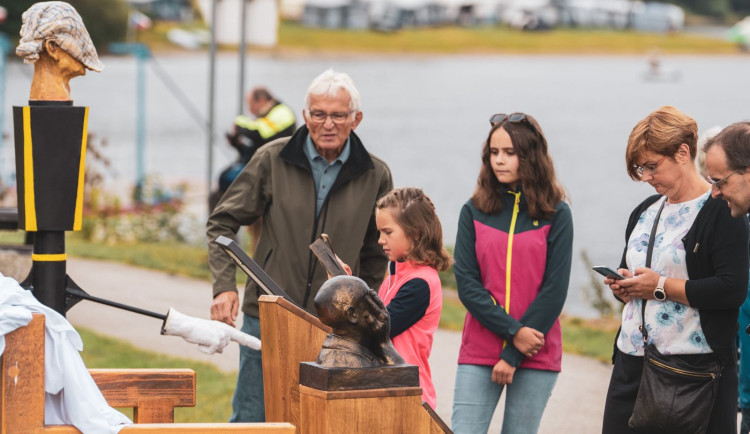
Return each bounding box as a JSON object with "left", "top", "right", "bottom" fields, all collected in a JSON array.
[{"left": 207, "top": 70, "right": 393, "bottom": 422}]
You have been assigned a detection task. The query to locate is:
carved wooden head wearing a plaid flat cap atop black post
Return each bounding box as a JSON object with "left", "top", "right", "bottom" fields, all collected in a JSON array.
[{"left": 16, "top": 1, "right": 104, "bottom": 100}]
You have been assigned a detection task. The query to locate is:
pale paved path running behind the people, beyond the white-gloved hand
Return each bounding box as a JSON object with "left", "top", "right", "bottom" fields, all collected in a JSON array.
[{"left": 5, "top": 258, "right": 611, "bottom": 434}]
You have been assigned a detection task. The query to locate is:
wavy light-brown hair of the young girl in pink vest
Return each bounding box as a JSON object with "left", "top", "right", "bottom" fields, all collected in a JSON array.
[{"left": 376, "top": 187, "right": 453, "bottom": 271}]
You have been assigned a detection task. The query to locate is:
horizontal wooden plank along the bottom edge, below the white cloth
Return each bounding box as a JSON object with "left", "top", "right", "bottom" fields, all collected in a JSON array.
[{"left": 38, "top": 423, "right": 295, "bottom": 434}]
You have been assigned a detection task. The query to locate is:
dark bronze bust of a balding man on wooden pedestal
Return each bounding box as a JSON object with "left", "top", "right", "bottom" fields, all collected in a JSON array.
[{"left": 315, "top": 276, "right": 404, "bottom": 368}]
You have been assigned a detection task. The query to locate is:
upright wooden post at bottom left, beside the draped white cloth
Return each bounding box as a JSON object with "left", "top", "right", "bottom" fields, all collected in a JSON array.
[{"left": 0, "top": 314, "right": 44, "bottom": 434}]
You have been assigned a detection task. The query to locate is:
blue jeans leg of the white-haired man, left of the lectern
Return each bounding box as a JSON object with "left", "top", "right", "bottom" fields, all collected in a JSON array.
[{"left": 229, "top": 313, "right": 266, "bottom": 422}]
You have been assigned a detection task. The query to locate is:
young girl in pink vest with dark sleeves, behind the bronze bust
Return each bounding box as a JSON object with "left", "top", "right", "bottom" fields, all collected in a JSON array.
[{"left": 375, "top": 187, "right": 452, "bottom": 408}]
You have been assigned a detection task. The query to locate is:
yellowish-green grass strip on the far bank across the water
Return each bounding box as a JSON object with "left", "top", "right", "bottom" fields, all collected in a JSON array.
[{"left": 139, "top": 21, "right": 738, "bottom": 55}]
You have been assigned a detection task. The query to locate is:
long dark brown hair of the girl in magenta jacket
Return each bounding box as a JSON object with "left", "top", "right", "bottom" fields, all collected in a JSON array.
[{"left": 471, "top": 115, "right": 566, "bottom": 219}]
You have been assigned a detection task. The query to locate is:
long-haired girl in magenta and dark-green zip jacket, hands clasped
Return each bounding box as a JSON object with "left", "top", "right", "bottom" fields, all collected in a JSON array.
[{"left": 452, "top": 113, "right": 573, "bottom": 434}]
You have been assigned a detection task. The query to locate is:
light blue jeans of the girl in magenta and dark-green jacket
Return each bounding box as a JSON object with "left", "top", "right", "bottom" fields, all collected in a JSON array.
[{"left": 451, "top": 365, "right": 558, "bottom": 434}]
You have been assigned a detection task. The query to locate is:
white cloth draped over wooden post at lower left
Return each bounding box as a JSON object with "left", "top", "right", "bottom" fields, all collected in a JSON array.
[{"left": 0, "top": 273, "right": 133, "bottom": 434}]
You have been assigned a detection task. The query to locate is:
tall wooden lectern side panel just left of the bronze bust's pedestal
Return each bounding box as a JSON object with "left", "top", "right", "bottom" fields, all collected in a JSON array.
[{"left": 259, "top": 295, "right": 331, "bottom": 426}]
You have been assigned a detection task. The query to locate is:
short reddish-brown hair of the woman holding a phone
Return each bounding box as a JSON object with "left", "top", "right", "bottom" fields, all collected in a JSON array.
[{"left": 625, "top": 106, "right": 698, "bottom": 181}]
